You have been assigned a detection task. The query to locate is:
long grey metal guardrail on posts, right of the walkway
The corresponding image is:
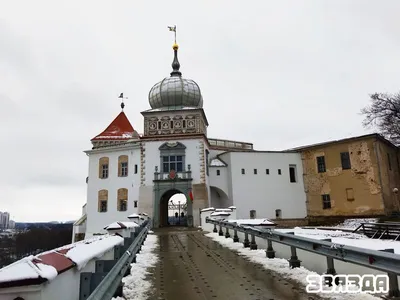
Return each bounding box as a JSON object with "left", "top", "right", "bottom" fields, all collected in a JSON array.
[{"left": 206, "top": 217, "right": 400, "bottom": 297}]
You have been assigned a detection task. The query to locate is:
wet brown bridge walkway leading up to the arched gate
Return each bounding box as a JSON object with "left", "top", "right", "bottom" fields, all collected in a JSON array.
[{"left": 149, "top": 227, "right": 319, "bottom": 300}]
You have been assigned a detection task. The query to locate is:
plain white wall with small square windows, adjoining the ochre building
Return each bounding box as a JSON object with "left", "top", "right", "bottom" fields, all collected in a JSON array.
[{"left": 221, "top": 152, "right": 306, "bottom": 219}]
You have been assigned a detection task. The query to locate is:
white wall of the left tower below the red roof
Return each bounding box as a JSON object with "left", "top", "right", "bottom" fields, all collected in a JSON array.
[{"left": 86, "top": 146, "right": 140, "bottom": 238}]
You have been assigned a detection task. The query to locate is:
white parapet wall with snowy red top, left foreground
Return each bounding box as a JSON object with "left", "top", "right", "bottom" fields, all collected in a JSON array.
[{"left": 0, "top": 234, "right": 124, "bottom": 300}]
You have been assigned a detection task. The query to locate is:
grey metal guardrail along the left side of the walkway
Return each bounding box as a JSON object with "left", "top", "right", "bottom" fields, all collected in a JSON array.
[{"left": 87, "top": 220, "right": 150, "bottom": 300}]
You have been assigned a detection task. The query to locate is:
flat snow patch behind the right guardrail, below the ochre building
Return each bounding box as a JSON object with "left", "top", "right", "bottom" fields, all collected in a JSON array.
[{"left": 276, "top": 227, "right": 400, "bottom": 254}]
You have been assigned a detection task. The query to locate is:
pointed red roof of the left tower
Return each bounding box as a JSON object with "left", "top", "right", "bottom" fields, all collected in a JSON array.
[{"left": 92, "top": 111, "right": 139, "bottom": 141}]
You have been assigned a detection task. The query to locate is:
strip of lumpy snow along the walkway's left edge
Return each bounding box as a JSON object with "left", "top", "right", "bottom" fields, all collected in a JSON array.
[{"left": 113, "top": 231, "right": 159, "bottom": 300}]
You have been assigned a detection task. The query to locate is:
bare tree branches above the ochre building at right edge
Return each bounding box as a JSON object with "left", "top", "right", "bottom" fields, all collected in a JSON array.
[{"left": 361, "top": 93, "right": 400, "bottom": 146}]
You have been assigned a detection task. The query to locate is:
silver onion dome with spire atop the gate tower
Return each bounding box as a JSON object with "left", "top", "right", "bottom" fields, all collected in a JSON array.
[{"left": 149, "top": 44, "right": 203, "bottom": 110}]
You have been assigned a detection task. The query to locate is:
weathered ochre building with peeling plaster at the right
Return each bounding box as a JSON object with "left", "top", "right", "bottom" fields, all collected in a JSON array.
[{"left": 291, "top": 134, "right": 400, "bottom": 218}]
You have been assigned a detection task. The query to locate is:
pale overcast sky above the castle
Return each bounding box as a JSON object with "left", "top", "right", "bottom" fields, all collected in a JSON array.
[{"left": 0, "top": 0, "right": 400, "bottom": 221}]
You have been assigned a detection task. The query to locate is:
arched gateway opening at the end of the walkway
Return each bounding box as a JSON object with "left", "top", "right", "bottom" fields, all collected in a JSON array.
[{"left": 159, "top": 189, "right": 188, "bottom": 227}]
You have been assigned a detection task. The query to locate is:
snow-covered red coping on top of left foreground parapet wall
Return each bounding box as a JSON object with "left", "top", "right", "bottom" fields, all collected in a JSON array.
[{"left": 0, "top": 234, "right": 124, "bottom": 287}]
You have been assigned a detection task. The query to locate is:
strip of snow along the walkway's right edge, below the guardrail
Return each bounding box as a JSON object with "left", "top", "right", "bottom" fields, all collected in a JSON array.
[{"left": 206, "top": 230, "right": 380, "bottom": 300}]
